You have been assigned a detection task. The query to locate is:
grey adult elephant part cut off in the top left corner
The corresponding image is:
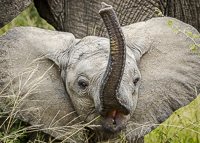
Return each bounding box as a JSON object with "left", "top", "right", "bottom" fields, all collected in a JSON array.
[{"left": 0, "top": 0, "right": 33, "bottom": 28}]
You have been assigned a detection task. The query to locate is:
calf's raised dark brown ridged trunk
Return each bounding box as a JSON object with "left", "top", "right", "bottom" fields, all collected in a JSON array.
[{"left": 99, "top": 3, "right": 130, "bottom": 115}]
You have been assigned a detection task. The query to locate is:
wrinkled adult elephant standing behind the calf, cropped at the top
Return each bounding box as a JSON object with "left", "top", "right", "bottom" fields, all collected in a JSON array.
[{"left": 0, "top": 0, "right": 200, "bottom": 38}]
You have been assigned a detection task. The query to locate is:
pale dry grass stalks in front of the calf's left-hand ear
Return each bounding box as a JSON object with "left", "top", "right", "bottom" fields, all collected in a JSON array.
[{"left": 0, "top": 58, "right": 90, "bottom": 143}]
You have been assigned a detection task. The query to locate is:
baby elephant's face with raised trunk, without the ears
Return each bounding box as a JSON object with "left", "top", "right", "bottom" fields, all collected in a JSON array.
[{"left": 62, "top": 3, "right": 140, "bottom": 132}]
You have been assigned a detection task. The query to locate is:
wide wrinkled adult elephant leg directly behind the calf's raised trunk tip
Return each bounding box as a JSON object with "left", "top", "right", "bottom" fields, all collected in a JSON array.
[{"left": 34, "top": 0, "right": 159, "bottom": 38}]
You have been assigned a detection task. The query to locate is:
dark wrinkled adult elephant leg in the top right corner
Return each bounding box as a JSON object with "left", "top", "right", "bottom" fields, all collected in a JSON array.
[{"left": 159, "top": 0, "right": 200, "bottom": 31}]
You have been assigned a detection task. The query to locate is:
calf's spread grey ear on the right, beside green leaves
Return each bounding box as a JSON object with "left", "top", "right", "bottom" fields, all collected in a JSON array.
[{"left": 123, "top": 18, "right": 200, "bottom": 140}]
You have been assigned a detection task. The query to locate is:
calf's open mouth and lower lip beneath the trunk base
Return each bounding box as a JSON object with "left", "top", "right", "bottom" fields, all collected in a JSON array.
[{"left": 101, "top": 110, "right": 130, "bottom": 133}]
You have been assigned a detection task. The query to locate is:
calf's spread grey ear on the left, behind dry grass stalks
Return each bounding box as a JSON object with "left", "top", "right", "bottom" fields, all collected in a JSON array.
[{"left": 0, "top": 27, "right": 82, "bottom": 139}]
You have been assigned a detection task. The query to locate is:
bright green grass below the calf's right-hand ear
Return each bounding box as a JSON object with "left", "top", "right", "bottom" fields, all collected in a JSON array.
[{"left": 145, "top": 96, "right": 200, "bottom": 143}]
